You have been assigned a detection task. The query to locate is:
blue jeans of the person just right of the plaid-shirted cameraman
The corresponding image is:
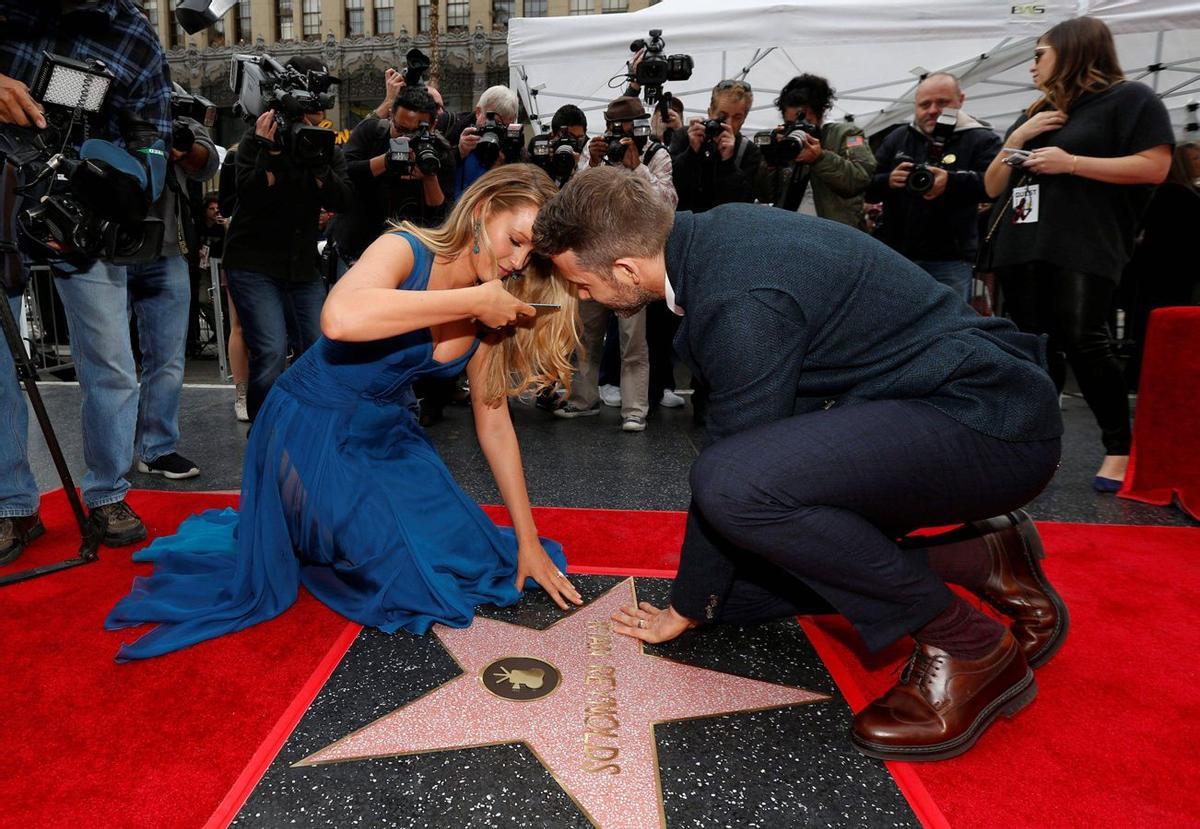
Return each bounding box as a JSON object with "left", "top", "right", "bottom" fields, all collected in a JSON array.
[{"left": 127, "top": 256, "right": 191, "bottom": 462}]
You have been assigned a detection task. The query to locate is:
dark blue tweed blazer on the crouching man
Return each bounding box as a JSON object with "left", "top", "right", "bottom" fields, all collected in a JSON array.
[{"left": 666, "top": 204, "right": 1062, "bottom": 441}]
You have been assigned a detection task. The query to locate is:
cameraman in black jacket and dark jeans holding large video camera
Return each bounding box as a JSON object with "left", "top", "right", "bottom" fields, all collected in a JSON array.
[{"left": 224, "top": 56, "right": 352, "bottom": 421}]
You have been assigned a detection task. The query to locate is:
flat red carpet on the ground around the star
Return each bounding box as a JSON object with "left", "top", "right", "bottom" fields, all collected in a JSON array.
[{"left": 0, "top": 492, "right": 1200, "bottom": 829}]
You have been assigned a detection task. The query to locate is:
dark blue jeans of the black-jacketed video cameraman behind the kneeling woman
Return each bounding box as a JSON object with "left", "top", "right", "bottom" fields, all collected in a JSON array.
[{"left": 229, "top": 270, "right": 325, "bottom": 420}]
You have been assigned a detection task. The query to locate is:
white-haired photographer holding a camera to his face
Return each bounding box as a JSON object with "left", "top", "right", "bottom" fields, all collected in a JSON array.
[{"left": 445, "top": 86, "right": 522, "bottom": 200}]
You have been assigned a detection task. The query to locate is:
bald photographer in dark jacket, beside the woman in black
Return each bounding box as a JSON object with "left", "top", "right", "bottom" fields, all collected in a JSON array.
[{"left": 866, "top": 72, "right": 1001, "bottom": 302}]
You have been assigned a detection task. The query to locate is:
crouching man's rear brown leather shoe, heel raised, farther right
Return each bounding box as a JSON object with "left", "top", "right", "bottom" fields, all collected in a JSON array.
[{"left": 972, "top": 510, "right": 1070, "bottom": 668}]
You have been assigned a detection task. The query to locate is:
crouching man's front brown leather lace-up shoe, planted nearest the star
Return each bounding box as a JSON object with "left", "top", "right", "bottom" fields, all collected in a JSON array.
[{"left": 851, "top": 632, "right": 1038, "bottom": 761}]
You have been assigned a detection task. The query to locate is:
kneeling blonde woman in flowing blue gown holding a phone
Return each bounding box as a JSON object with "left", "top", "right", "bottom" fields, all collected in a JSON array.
[{"left": 104, "top": 164, "right": 582, "bottom": 660}]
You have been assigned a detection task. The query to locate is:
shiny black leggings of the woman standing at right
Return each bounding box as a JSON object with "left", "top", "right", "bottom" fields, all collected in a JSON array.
[{"left": 997, "top": 262, "right": 1133, "bottom": 455}]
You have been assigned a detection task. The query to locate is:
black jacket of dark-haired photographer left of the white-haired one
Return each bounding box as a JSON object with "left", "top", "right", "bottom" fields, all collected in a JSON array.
[{"left": 331, "top": 118, "right": 455, "bottom": 259}]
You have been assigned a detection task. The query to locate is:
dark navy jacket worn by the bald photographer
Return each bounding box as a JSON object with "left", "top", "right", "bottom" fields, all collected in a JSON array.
[{"left": 866, "top": 114, "right": 1001, "bottom": 262}]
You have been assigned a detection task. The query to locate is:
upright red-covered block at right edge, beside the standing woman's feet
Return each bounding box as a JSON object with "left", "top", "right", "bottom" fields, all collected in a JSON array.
[{"left": 1121, "top": 308, "right": 1200, "bottom": 519}]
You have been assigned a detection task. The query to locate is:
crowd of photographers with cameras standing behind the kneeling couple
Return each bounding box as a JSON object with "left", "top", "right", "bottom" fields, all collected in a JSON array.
[{"left": 0, "top": 6, "right": 1190, "bottom": 563}]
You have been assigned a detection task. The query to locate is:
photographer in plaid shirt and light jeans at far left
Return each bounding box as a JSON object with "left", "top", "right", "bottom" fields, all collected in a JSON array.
[{"left": 0, "top": 0, "right": 170, "bottom": 564}]
